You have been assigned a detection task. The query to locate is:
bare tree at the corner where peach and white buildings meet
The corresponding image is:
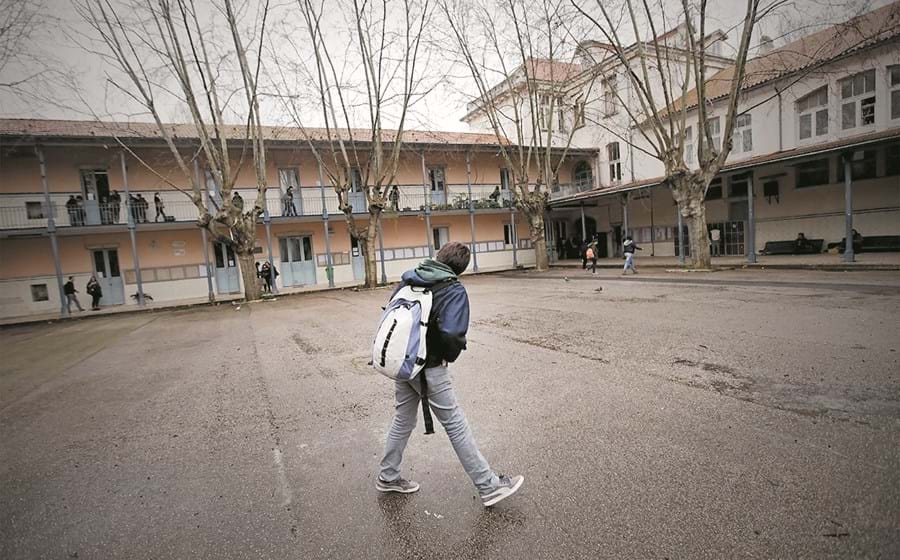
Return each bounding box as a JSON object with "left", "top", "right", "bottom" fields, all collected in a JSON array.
[{"left": 440, "top": 0, "right": 595, "bottom": 270}]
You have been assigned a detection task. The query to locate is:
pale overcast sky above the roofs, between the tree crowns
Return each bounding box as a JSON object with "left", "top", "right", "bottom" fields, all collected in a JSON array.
[{"left": 0, "top": 0, "right": 890, "bottom": 131}]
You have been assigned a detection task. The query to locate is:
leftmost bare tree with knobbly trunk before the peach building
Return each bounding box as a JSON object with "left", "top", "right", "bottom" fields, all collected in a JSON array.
[{"left": 76, "top": 0, "right": 269, "bottom": 300}]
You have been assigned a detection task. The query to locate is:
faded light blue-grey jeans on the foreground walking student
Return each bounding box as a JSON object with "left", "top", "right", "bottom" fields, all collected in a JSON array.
[{"left": 380, "top": 366, "right": 500, "bottom": 494}]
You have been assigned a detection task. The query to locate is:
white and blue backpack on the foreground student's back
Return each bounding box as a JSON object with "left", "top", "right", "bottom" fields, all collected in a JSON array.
[{"left": 372, "top": 281, "right": 454, "bottom": 381}]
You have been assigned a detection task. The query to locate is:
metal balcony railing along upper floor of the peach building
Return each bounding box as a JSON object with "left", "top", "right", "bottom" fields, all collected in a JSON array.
[{"left": 0, "top": 184, "right": 568, "bottom": 230}]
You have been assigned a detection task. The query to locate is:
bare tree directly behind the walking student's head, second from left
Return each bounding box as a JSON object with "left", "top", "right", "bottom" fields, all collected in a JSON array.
[{"left": 273, "top": 0, "right": 432, "bottom": 287}]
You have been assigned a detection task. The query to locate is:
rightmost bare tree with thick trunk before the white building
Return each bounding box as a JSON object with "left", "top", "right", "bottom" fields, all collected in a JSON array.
[{"left": 572, "top": 0, "right": 768, "bottom": 268}]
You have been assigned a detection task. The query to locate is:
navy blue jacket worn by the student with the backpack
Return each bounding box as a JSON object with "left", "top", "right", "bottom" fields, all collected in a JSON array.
[{"left": 391, "top": 269, "right": 469, "bottom": 368}]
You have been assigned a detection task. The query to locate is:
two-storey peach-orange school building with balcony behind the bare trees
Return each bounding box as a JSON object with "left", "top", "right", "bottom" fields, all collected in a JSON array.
[{"left": 0, "top": 119, "right": 596, "bottom": 317}]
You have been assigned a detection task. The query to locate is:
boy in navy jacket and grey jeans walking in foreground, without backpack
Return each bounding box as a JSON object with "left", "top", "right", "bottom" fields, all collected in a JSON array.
[{"left": 375, "top": 241, "right": 525, "bottom": 507}]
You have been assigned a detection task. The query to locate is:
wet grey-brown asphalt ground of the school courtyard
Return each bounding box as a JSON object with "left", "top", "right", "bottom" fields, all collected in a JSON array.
[{"left": 0, "top": 270, "right": 900, "bottom": 559}]
